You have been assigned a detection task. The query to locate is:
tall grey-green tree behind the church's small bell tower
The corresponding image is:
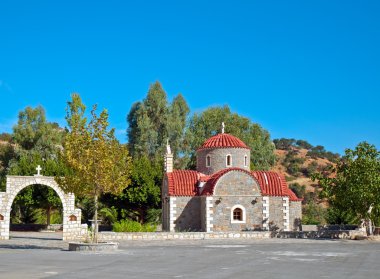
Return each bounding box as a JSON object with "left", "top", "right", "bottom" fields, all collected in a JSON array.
[{"left": 127, "top": 82, "right": 189, "bottom": 166}]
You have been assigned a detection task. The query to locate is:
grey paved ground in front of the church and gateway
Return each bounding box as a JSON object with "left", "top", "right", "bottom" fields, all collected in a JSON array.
[{"left": 0, "top": 232, "right": 380, "bottom": 279}]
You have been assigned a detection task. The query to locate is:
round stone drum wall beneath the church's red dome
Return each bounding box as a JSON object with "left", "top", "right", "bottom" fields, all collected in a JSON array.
[{"left": 197, "top": 148, "right": 251, "bottom": 175}]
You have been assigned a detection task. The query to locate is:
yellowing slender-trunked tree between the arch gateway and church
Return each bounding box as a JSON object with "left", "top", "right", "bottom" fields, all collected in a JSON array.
[{"left": 56, "top": 94, "right": 131, "bottom": 242}]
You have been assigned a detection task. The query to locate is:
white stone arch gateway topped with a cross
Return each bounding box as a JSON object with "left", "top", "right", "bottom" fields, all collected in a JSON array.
[{"left": 0, "top": 175, "right": 87, "bottom": 240}]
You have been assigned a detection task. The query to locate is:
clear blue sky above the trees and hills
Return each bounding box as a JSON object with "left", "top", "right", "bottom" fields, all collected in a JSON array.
[{"left": 0, "top": 0, "right": 380, "bottom": 153}]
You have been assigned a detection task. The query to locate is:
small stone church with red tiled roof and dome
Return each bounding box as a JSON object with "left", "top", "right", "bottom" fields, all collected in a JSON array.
[{"left": 162, "top": 125, "right": 302, "bottom": 232}]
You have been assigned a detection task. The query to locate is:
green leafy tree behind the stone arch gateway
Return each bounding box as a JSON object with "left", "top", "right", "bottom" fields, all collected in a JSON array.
[{"left": 0, "top": 106, "right": 64, "bottom": 225}]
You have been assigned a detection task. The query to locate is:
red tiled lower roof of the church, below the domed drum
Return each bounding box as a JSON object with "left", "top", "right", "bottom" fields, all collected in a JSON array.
[{"left": 166, "top": 168, "right": 301, "bottom": 201}]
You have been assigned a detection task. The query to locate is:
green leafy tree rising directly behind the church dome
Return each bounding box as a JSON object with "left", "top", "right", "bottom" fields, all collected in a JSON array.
[{"left": 186, "top": 106, "right": 276, "bottom": 170}]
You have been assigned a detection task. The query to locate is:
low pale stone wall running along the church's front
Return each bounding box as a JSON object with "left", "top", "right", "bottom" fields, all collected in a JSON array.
[{"left": 98, "top": 231, "right": 271, "bottom": 241}]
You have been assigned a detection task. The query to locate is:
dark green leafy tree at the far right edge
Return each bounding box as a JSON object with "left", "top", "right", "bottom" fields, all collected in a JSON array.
[{"left": 313, "top": 142, "right": 380, "bottom": 233}]
